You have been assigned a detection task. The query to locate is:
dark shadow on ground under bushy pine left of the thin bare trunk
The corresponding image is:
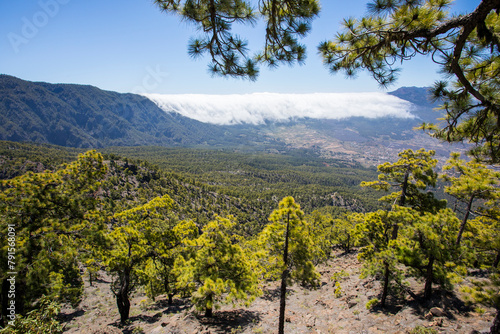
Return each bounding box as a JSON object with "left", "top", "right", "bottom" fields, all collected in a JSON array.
[{"left": 197, "top": 309, "right": 261, "bottom": 333}]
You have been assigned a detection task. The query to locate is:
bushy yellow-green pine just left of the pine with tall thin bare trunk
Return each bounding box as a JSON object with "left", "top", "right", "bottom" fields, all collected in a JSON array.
[{"left": 175, "top": 217, "right": 260, "bottom": 317}]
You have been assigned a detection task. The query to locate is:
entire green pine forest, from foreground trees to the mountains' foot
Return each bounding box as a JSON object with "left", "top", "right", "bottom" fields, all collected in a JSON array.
[{"left": 0, "top": 142, "right": 500, "bottom": 333}]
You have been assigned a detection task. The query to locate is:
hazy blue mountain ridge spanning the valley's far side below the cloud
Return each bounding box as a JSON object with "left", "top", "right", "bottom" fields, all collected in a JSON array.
[{"left": 0, "top": 75, "right": 447, "bottom": 163}]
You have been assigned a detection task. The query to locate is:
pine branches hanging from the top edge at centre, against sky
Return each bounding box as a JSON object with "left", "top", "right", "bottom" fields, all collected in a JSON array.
[{"left": 155, "top": 0, "right": 319, "bottom": 80}]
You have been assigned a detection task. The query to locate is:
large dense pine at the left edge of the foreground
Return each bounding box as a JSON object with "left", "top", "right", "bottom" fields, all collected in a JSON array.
[{"left": 0, "top": 151, "right": 106, "bottom": 319}]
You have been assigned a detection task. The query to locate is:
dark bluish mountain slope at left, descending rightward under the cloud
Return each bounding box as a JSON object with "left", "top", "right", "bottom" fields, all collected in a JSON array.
[{"left": 0, "top": 75, "right": 276, "bottom": 147}]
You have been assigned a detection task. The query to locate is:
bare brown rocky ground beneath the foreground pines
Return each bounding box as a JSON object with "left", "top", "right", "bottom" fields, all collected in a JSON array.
[{"left": 61, "top": 253, "right": 495, "bottom": 334}]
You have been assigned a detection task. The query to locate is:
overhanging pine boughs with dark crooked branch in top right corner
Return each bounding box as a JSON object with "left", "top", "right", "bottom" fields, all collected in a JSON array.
[{"left": 319, "top": 0, "right": 500, "bottom": 163}]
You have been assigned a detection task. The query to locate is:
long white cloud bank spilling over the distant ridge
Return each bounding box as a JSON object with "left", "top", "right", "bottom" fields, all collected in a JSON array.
[{"left": 144, "top": 93, "right": 414, "bottom": 125}]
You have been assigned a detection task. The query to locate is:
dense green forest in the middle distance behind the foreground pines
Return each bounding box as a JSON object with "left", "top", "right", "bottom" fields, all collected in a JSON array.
[{"left": 0, "top": 142, "right": 380, "bottom": 228}]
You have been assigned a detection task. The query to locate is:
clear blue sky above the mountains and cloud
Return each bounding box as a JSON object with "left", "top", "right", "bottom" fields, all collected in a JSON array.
[{"left": 0, "top": 0, "right": 479, "bottom": 94}]
